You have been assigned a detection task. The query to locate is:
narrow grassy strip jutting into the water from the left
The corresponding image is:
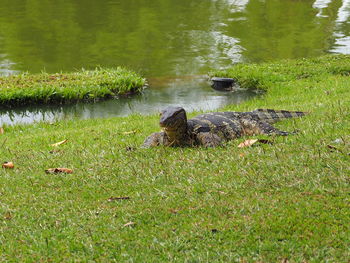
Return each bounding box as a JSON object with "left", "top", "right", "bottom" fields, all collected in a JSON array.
[{"left": 0, "top": 67, "right": 145, "bottom": 106}]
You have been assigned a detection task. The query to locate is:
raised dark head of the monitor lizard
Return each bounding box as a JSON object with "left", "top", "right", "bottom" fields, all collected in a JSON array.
[{"left": 159, "top": 107, "right": 187, "bottom": 130}]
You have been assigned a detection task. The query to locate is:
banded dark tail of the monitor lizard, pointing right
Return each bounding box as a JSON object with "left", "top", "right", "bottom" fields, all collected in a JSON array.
[{"left": 252, "top": 109, "right": 308, "bottom": 123}]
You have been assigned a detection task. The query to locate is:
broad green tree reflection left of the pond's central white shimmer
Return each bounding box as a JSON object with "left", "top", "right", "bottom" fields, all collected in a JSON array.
[{"left": 0, "top": 0, "right": 223, "bottom": 76}]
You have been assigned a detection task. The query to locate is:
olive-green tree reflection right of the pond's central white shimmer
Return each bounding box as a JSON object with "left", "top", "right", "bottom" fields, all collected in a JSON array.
[{"left": 229, "top": 0, "right": 341, "bottom": 61}]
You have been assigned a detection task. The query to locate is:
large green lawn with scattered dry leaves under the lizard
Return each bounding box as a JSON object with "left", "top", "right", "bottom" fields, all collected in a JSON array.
[{"left": 0, "top": 56, "right": 350, "bottom": 262}]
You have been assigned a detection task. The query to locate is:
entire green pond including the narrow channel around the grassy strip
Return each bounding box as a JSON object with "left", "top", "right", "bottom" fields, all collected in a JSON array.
[{"left": 0, "top": 0, "right": 350, "bottom": 123}]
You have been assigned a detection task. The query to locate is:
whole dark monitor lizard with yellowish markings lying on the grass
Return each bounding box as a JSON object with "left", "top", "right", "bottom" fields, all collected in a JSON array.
[{"left": 143, "top": 107, "right": 306, "bottom": 147}]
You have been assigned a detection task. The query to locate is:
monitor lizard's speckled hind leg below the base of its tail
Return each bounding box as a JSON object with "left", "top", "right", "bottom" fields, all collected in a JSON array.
[{"left": 241, "top": 119, "right": 291, "bottom": 136}]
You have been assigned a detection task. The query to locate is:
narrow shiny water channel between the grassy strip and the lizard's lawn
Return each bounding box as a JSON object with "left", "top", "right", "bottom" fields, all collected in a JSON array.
[{"left": 0, "top": 76, "right": 257, "bottom": 127}]
